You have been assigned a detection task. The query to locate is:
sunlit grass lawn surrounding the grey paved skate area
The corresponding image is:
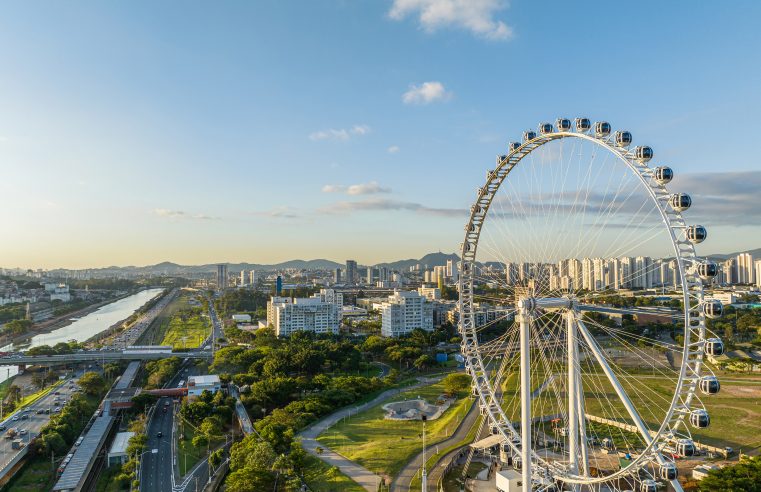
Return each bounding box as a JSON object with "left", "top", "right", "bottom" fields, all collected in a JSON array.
[{"left": 318, "top": 382, "right": 471, "bottom": 477}]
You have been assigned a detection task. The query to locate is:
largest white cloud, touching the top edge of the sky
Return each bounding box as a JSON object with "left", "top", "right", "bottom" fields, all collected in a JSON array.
[{"left": 388, "top": 0, "right": 513, "bottom": 40}]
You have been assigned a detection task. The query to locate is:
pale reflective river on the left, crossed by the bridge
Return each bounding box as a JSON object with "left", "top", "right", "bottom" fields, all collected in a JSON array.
[{"left": 0, "top": 289, "right": 164, "bottom": 382}]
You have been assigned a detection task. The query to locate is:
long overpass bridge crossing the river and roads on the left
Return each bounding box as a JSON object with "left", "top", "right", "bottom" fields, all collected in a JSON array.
[{"left": 0, "top": 350, "right": 213, "bottom": 366}]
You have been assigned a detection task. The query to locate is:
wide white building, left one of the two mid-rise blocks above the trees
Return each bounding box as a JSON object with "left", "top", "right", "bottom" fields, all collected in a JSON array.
[{"left": 267, "top": 289, "right": 343, "bottom": 337}]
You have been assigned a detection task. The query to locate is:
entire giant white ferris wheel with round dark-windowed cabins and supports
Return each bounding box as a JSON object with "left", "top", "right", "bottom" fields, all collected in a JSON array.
[{"left": 459, "top": 118, "right": 724, "bottom": 492}]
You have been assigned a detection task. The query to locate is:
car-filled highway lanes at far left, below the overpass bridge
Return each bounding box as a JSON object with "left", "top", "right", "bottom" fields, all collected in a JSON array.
[{"left": 0, "top": 378, "right": 78, "bottom": 469}]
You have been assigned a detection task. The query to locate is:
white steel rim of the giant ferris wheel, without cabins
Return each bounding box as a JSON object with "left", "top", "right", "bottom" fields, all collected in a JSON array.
[{"left": 458, "top": 127, "right": 706, "bottom": 485}]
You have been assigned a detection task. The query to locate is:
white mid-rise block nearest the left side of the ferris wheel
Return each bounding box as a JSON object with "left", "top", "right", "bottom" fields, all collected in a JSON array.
[{"left": 380, "top": 291, "right": 433, "bottom": 337}]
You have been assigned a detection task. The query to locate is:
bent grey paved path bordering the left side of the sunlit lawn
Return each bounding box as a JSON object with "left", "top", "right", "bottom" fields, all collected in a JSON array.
[{"left": 299, "top": 376, "right": 444, "bottom": 492}]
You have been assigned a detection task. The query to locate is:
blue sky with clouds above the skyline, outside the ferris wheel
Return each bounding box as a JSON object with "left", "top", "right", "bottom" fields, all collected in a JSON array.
[{"left": 0, "top": 0, "right": 761, "bottom": 268}]
